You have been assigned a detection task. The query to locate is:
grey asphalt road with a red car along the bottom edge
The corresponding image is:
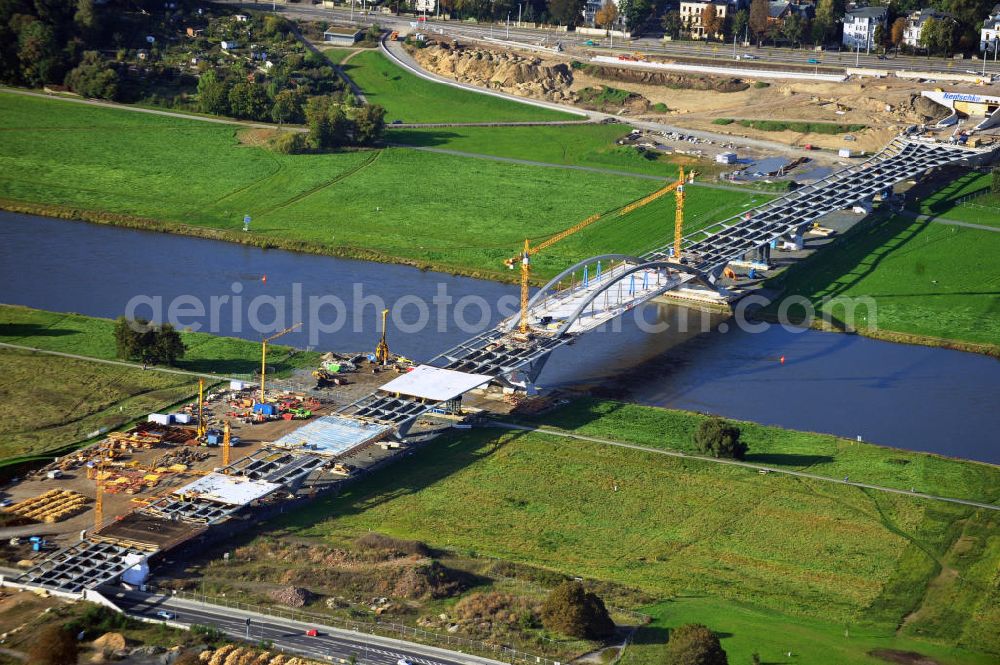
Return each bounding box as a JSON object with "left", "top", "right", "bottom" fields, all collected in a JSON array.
[{"left": 111, "top": 587, "right": 497, "bottom": 665}]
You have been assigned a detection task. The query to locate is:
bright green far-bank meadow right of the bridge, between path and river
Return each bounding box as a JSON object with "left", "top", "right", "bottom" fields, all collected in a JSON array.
[{"left": 764, "top": 216, "right": 1000, "bottom": 347}]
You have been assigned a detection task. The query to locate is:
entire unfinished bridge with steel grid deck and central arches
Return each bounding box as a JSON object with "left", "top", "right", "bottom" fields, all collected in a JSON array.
[{"left": 4, "top": 136, "right": 993, "bottom": 597}]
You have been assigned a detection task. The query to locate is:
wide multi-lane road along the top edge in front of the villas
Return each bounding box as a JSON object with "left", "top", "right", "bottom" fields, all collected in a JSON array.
[{"left": 223, "top": 0, "right": 1000, "bottom": 75}]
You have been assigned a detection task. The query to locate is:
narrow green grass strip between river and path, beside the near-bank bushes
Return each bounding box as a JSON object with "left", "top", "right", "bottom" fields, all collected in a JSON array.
[{"left": 0, "top": 304, "right": 320, "bottom": 376}]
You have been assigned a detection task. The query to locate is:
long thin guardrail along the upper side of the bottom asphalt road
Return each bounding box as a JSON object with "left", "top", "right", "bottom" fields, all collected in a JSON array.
[{"left": 146, "top": 586, "right": 562, "bottom": 665}]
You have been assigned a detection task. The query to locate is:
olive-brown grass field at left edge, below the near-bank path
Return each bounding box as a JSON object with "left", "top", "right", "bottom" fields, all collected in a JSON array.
[{"left": 0, "top": 348, "right": 198, "bottom": 466}]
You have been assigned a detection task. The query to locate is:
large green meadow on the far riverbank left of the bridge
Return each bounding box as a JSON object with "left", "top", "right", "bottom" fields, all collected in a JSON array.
[{"left": 0, "top": 94, "right": 752, "bottom": 279}]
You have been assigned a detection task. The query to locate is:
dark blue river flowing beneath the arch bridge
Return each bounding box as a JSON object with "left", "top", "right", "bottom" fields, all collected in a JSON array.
[{"left": 0, "top": 212, "right": 1000, "bottom": 463}]
